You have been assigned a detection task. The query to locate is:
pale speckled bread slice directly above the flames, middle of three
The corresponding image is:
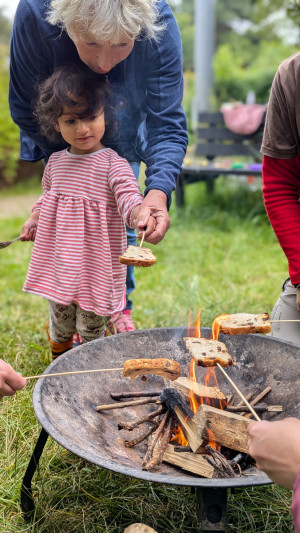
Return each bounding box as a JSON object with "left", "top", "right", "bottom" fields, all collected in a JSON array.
[{"left": 183, "top": 337, "right": 234, "bottom": 367}]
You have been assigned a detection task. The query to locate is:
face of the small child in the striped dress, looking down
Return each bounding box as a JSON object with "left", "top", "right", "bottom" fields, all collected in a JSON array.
[{"left": 54, "top": 107, "right": 105, "bottom": 154}]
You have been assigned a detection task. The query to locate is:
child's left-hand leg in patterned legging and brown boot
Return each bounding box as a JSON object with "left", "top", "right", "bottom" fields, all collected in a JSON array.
[{"left": 49, "top": 300, "right": 76, "bottom": 359}]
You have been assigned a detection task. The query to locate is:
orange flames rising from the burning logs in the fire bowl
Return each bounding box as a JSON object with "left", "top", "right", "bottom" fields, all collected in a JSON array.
[{"left": 171, "top": 309, "right": 223, "bottom": 448}]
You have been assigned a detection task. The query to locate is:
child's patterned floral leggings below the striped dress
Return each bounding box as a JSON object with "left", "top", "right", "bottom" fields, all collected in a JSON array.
[{"left": 49, "top": 300, "right": 105, "bottom": 342}]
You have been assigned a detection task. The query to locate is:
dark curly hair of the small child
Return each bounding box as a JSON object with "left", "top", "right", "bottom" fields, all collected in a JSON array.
[{"left": 33, "top": 64, "right": 115, "bottom": 142}]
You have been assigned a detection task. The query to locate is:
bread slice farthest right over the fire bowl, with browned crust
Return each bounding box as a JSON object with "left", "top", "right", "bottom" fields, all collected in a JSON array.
[{"left": 212, "top": 313, "right": 271, "bottom": 335}]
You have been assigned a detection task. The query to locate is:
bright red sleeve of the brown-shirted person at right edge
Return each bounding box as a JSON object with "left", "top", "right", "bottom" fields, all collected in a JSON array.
[{"left": 262, "top": 155, "right": 300, "bottom": 284}]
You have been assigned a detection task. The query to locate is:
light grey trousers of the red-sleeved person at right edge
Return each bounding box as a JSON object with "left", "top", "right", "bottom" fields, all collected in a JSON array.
[{"left": 268, "top": 278, "right": 300, "bottom": 345}]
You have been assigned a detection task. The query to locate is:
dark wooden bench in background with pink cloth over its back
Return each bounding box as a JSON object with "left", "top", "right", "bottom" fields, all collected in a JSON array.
[{"left": 175, "top": 112, "right": 265, "bottom": 207}]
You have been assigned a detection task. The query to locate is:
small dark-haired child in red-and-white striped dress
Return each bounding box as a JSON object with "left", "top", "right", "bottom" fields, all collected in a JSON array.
[{"left": 21, "top": 64, "right": 156, "bottom": 358}]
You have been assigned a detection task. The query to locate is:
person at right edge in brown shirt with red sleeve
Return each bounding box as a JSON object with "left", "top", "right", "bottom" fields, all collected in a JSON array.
[{"left": 261, "top": 52, "right": 300, "bottom": 344}]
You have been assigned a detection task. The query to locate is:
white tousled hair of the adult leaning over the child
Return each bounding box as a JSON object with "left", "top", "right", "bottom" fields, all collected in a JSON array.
[{"left": 47, "top": 0, "right": 165, "bottom": 41}]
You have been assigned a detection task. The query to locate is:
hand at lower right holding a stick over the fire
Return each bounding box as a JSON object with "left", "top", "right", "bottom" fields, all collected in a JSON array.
[{"left": 248, "top": 418, "right": 300, "bottom": 489}]
